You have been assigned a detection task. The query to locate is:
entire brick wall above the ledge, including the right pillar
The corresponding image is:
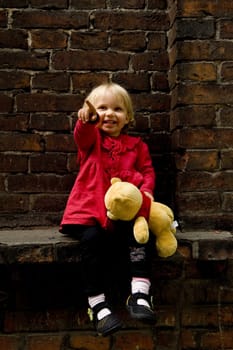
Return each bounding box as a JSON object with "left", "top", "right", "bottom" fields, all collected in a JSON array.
[{"left": 0, "top": 0, "right": 233, "bottom": 229}]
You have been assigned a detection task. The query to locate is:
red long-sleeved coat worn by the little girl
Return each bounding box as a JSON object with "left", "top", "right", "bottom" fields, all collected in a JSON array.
[{"left": 61, "top": 120, "right": 155, "bottom": 227}]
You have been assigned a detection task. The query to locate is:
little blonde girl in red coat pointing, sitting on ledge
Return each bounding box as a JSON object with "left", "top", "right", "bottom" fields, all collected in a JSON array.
[{"left": 60, "top": 83, "right": 155, "bottom": 336}]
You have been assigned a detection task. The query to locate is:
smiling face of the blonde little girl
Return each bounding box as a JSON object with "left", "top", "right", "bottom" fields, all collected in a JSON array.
[{"left": 94, "top": 89, "right": 129, "bottom": 137}]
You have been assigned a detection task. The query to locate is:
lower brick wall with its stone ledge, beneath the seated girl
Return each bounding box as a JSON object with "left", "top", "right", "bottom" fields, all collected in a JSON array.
[{"left": 0, "top": 229, "right": 233, "bottom": 350}]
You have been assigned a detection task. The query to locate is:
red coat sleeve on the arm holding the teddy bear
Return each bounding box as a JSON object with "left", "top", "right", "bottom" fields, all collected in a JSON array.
[{"left": 137, "top": 141, "right": 156, "bottom": 195}]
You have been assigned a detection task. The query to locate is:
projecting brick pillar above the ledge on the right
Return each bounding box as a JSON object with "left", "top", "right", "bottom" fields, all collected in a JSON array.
[{"left": 172, "top": 0, "right": 233, "bottom": 230}]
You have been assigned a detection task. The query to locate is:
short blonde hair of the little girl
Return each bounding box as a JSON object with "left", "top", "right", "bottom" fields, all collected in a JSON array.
[{"left": 86, "top": 82, "right": 135, "bottom": 124}]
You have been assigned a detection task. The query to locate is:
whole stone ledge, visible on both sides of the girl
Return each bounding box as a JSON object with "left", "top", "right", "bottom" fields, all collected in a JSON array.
[{"left": 0, "top": 227, "right": 233, "bottom": 264}]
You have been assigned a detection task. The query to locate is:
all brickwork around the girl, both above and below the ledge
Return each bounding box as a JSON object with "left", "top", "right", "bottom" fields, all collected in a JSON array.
[{"left": 0, "top": 0, "right": 233, "bottom": 350}]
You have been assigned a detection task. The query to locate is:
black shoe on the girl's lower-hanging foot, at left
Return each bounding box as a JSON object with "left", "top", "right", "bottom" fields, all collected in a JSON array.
[{"left": 90, "top": 302, "right": 122, "bottom": 337}]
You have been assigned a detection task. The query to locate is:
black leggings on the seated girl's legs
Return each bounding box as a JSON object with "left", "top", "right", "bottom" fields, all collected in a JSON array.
[{"left": 62, "top": 221, "right": 154, "bottom": 296}]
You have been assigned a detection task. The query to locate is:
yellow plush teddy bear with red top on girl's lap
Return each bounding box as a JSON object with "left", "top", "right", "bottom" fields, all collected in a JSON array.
[{"left": 104, "top": 178, "right": 177, "bottom": 258}]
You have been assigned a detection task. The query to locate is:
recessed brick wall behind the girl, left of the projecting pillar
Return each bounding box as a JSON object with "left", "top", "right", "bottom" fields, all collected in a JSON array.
[{"left": 0, "top": 0, "right": 174, "bottom": 227}]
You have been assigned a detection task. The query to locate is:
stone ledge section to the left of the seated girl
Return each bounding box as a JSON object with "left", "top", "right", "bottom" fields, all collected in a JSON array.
[{"left": 0, "top": 227, "right": 80, "bottom": 264}]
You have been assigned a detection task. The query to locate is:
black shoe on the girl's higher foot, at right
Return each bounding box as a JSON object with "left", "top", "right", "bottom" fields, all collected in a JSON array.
[{"left": 126, "top": 293, "right": 156, "bottom": 323}]
